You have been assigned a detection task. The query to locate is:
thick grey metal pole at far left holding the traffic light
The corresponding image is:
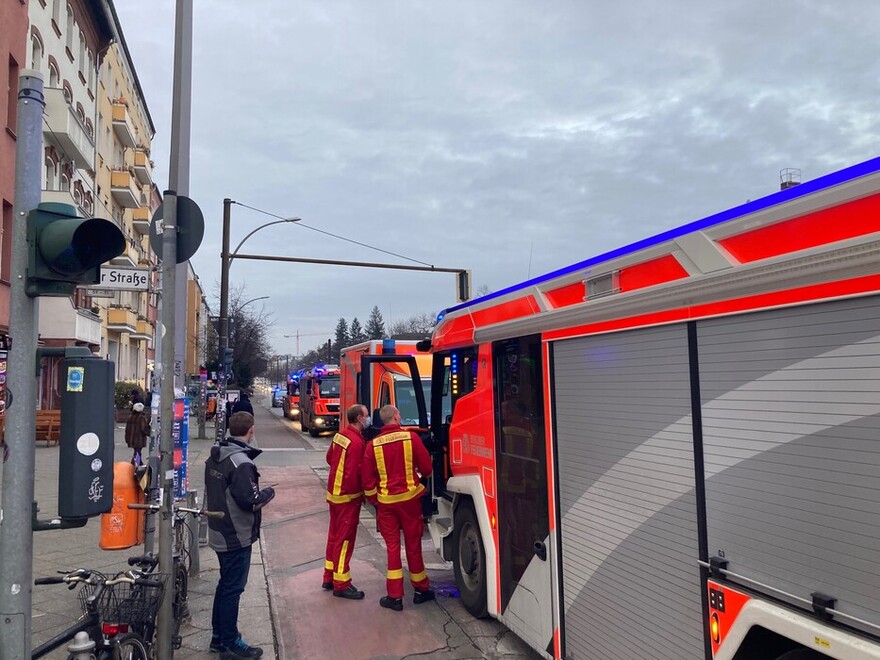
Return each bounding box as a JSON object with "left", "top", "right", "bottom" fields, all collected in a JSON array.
[{"left": 0, "top": 69, "right": 45, "bottom": 658}]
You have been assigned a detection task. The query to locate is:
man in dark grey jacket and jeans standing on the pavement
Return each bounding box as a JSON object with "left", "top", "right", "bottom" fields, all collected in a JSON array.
[{"left": 205, "top": 412, "right": 275, "bottom": 660}]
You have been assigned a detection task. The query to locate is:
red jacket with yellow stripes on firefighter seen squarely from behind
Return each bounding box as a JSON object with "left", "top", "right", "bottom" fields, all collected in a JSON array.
[{"left": 362, "top": 424, "right": 431, "bottom": 504}]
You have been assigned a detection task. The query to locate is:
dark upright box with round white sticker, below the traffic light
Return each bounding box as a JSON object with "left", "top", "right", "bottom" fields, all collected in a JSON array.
[{"left": 58, "top": 356, "right": 115, "bottom": 518}]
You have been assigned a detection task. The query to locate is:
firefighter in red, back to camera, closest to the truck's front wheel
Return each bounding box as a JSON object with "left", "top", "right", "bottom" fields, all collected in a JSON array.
[{"left": 361, "top": 405, "right": 434, "bottom": 612}]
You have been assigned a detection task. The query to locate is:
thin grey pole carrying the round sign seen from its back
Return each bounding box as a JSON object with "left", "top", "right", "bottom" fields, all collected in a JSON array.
[{"left": 157, "top": 190, "right": 177, "bottom": 658}]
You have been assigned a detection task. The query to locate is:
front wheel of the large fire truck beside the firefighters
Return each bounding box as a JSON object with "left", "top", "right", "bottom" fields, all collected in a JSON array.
[{"left": 452, "top": 501, "right": 489, "bottom": 619}]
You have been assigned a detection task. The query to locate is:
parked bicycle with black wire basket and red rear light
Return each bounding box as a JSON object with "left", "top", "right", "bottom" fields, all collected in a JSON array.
[{"left": 31, "top": 568, "right": 165, "bottom": 660}]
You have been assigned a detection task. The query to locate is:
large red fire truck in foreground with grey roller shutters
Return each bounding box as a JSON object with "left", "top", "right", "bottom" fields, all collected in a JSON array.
[{"left": 396, "top": 159, "right": 880, "bottom": 660}]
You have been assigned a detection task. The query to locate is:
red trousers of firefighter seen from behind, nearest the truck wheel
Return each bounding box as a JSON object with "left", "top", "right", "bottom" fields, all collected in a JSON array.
[{"left": 376, "top": 497, "right": 430, "bottom": 598}]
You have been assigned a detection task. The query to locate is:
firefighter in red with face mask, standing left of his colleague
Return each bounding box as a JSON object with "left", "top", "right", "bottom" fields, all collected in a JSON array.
[{"left": 322, "top": 403, "right": 370, "bottom": 600}]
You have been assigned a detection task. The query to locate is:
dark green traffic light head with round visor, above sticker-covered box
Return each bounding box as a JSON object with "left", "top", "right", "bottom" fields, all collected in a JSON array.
[{"left": 25, "top": 202, "right": 125, "bottom": 298}]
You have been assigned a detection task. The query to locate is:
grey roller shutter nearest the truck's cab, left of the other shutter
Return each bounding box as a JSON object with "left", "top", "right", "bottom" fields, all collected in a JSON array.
[{"left": 553, "top": 325, "right": 704, "bottom": 660}]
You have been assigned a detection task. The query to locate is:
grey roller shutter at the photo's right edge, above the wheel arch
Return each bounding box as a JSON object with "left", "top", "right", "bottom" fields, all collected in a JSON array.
[{"left": 698, "top": 296, "right": 880, "bottom": 632}]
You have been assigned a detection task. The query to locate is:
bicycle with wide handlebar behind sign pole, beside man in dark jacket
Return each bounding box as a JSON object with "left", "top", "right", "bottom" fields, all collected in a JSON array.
[{"left": 128, "top": 503, "right": 226, "bottom": 649}]
